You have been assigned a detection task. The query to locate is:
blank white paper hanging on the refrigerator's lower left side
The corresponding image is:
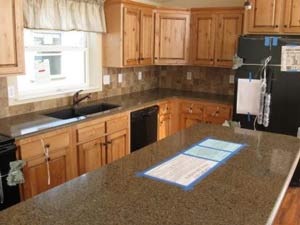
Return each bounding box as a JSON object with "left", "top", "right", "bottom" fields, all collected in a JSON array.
[{"left": 237, "top": 79, "right": 261, "bottom": 115}]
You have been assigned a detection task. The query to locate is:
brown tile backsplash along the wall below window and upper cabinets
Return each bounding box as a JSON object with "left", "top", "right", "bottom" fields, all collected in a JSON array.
[{"left": 0, "top": 66, "right": 233, "bottom": 118}]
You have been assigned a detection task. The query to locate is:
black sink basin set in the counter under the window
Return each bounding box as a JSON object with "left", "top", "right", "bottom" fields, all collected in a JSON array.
[{"left": 45, "top": 103, "right": 119, "bottom": 120}]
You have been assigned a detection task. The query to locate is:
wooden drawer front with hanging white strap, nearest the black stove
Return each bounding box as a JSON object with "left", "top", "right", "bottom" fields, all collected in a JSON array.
[{"left": 20, "top": 133, "right": 70, "bottom": 160}]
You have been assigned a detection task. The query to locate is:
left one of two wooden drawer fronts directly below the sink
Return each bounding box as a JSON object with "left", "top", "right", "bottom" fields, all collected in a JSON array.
[{"left": 77, "top": 122, "right": 105, "bottom": 142}]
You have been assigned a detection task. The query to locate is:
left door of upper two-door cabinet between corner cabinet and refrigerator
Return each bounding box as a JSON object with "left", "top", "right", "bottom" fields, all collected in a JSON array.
[{"left": 191, "top": 13, "right": 216, "bottom": 66}]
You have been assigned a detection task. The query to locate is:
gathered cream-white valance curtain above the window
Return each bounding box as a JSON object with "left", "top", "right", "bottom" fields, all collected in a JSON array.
[{"left": 23, "top": 0, "right": 106, "bottom": 33}]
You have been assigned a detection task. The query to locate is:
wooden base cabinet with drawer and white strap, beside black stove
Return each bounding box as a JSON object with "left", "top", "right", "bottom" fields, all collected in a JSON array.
[{"left": 18, "top": 129, "right": 77, "bottom": 199}]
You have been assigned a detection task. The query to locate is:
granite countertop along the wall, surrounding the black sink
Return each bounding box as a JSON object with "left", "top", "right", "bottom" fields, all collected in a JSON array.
[{"left": 0, "top": 89, "right": 233, "bottom": 139}]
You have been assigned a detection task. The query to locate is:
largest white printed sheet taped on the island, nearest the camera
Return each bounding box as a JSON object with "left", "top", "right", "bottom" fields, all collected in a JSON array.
[{"left": 145, "top": 154, "right": 217, "bottom": 186}]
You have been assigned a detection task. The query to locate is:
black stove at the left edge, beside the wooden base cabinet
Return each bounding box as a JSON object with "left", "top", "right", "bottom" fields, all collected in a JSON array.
[{"left": 0, "top": 135, "right": 20, "bottom": 211}]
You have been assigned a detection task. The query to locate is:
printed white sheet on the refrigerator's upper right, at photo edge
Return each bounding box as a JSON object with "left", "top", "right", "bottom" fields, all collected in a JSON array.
[{"left": 281, "top": 45, "right": 300, "bottom": 72}]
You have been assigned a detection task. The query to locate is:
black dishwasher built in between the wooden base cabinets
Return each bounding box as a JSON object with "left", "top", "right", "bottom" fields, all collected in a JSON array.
[{"left": 131, "top": 106, "right": 159, "bottom": 152}]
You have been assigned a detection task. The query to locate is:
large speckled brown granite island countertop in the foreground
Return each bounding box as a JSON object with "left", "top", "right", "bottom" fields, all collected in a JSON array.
[{"left": 0, "top": 124, "right": 300, "bottom": 225}]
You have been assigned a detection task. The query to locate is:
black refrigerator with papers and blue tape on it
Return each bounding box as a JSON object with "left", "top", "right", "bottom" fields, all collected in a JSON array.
[{"left": 233, "top": 35, "right": 300, "bottom": 187}]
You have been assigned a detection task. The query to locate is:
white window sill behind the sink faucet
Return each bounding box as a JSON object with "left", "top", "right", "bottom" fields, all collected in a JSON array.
[{"left": 9, "top": 87, "right": 102, "bottom": 106}]
